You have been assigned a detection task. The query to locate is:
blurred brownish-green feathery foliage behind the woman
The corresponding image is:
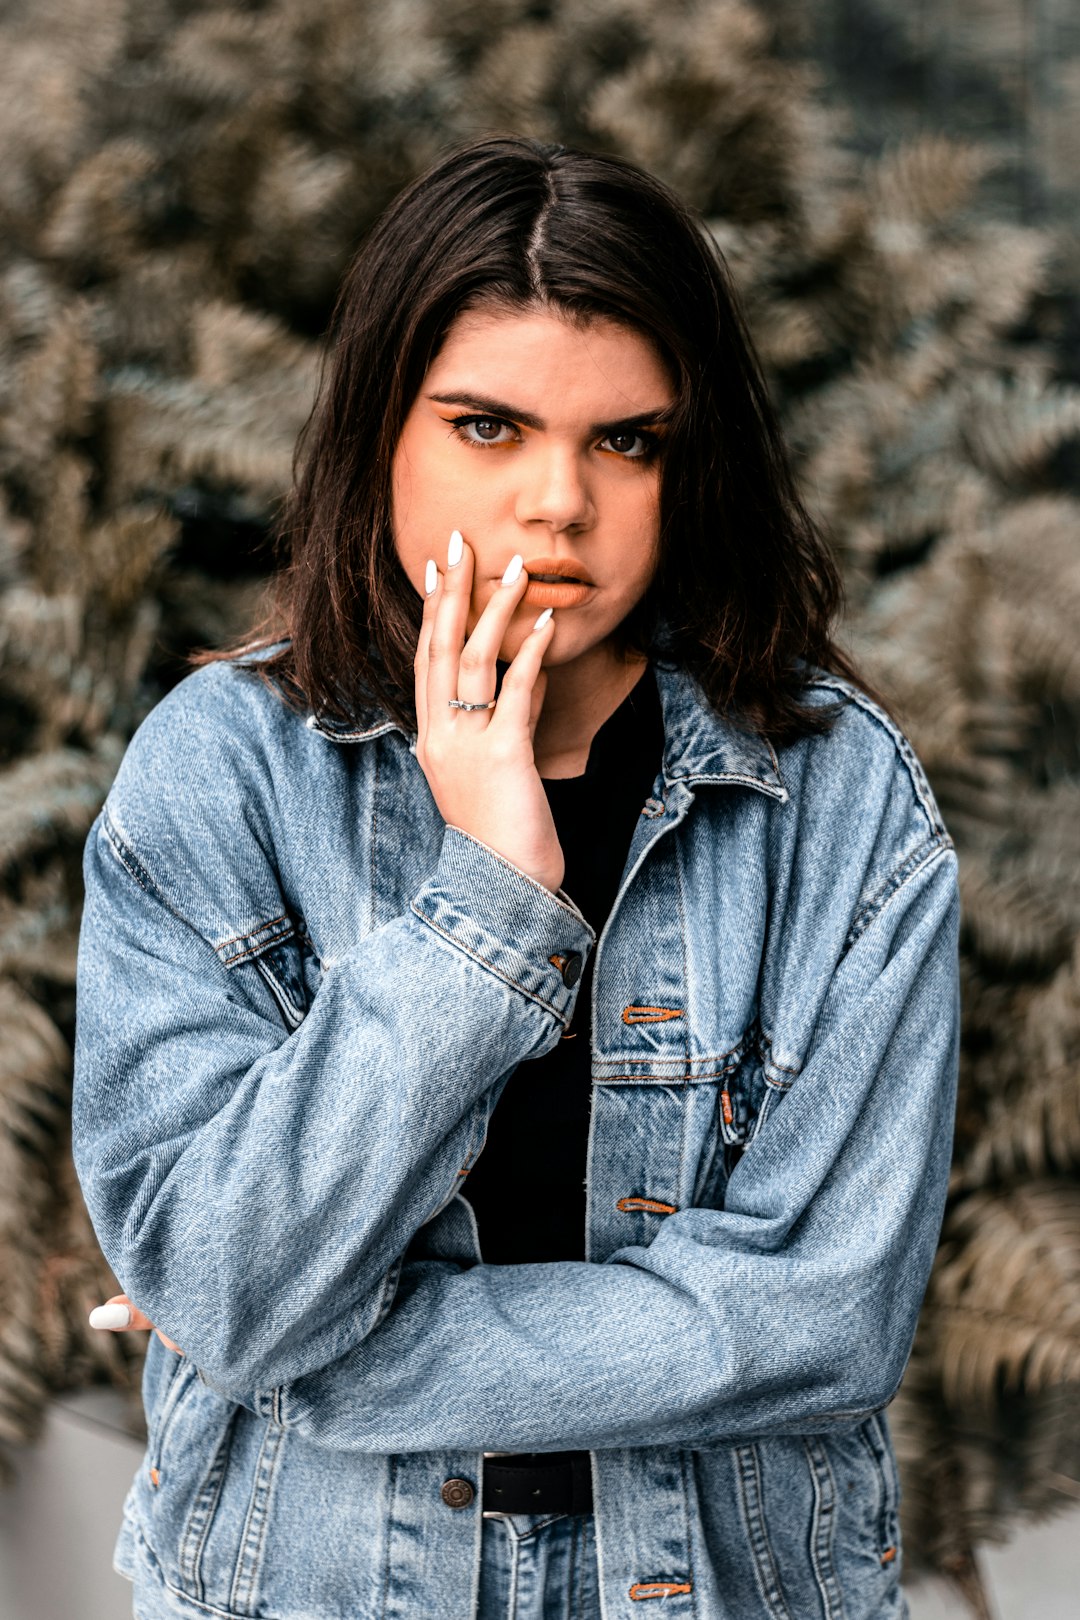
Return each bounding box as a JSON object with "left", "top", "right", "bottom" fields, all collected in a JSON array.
[{"left": 0, "top": 0, "right": 1080, "bottom": 1601}]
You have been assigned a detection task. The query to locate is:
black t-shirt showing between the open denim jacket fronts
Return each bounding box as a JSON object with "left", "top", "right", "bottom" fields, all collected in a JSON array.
[{"left": 461, "top": 667, "right": 664, "bottom": 1265}]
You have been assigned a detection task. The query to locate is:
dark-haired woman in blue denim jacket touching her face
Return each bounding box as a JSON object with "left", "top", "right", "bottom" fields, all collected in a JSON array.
[{"left": 74, "top": 139, "right": 957, "bottom": 1620}]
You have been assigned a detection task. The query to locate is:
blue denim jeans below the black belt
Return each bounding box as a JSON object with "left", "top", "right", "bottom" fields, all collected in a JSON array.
[{"left": 476, "top": 1513, "right": 601, "bottom": 1620}]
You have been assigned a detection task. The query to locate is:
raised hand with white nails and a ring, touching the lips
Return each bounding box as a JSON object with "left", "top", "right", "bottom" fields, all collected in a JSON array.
[{"left": 415, "top": 531, "right": 565, "bottom": 893}]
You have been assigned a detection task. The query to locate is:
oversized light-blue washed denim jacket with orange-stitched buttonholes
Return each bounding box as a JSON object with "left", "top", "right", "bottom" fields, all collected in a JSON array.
[{"left": 74, "top": 664, "right": 959, "bottom": 1620}]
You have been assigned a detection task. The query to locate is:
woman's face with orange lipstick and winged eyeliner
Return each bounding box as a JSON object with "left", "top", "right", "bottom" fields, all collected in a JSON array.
[{"left": 393, "top": 309, "right": 675, "bottom": 666}]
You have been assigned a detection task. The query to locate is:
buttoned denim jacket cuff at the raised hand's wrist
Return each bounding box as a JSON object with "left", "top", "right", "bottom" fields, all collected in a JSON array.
[{"left": 413, "top": 826, "right": 596, "bottom": 1024}]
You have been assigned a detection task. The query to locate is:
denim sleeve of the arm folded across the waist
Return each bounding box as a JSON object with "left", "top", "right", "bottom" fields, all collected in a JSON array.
[{"left": 280, "top": 846, "right": 959, "bottom": 1452}]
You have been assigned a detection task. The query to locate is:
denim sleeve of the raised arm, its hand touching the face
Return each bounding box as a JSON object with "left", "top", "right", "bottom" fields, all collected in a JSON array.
[{"left": 73, "top": 812, "right": 593, "bottom": 1390}]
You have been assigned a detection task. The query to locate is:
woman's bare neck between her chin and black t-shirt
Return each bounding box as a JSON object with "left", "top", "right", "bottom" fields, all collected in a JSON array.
[{"left": 533, "top": 643, "right": 648, "bottom": 778}]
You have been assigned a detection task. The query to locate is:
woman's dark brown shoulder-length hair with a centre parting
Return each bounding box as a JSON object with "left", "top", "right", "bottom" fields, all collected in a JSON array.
[{"left": 202, "top": 136, "right": 866, "bottom": 742}]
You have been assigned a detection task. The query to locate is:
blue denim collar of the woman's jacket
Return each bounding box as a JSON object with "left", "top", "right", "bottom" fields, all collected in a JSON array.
[{"left": 308, "top": 663, "right": 787, "bottom": 804}]
